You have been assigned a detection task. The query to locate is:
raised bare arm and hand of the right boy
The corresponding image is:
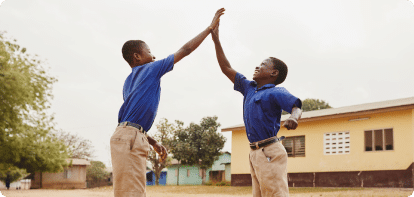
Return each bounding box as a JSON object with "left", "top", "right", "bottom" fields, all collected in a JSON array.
[{"left": 211, "top": 20, "right": 237, "bottom": 83}]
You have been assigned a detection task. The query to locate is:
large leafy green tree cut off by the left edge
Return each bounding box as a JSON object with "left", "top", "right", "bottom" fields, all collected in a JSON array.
[{"left": 0, "top": 32, "right": 67, "bottom": 172}]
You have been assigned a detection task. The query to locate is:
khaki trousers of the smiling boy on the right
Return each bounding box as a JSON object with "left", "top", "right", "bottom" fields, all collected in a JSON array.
[{"left": 249, "top": 142, "right": 289, "bottom": 197}]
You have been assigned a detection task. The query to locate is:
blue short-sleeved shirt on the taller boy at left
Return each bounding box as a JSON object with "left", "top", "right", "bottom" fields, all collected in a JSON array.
[{"left": 118, "top": 54, "right": 174, "bottom": 131}]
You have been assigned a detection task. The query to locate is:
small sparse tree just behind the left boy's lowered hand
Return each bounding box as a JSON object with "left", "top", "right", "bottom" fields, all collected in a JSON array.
[{"left": 148, "top": 118, "right": 183, "bottom": 185}]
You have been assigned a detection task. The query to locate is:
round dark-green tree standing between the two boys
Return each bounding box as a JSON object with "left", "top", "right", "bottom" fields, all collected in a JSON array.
[{"left": 171, "top": 116, "right": 226, "bottom": 182}]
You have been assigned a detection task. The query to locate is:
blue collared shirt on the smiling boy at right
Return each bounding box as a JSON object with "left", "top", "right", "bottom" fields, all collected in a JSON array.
[{"left": 234, "top": 73, "right": 302, "bottom": 143}]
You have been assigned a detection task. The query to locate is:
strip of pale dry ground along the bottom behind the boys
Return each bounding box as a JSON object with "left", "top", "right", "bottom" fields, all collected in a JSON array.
[{"left": 0, "top": 186, "right": 413, "bottom": 197}]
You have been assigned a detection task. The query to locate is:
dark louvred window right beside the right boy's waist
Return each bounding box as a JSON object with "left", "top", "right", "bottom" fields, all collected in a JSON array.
[{"left": 282, "top": 136, "right": 305, "bottom": 157}]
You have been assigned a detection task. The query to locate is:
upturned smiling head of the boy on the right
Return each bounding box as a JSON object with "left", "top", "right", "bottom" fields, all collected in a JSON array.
[{"left": 253, "top": 57, "right": 288, "bottom": 85}]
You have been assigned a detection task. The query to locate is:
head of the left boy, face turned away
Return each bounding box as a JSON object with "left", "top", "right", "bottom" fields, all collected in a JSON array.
[{"left": 122, "top": 40, "right": 155, "bottom": 67}]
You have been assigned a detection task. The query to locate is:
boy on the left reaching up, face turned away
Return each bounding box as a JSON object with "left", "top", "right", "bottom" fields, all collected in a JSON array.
[{"left": 111, "top": 8, "right": 224, "bottom": 197}]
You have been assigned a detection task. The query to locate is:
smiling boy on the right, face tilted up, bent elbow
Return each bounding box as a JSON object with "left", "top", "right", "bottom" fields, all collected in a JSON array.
[{"left": 211, "top": 19, "right": 302, "bottom": 197}]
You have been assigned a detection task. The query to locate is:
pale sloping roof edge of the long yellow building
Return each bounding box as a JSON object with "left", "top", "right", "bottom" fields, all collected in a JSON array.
[{"left": 221, "top": 97, "right": 414, "bottom": 132}]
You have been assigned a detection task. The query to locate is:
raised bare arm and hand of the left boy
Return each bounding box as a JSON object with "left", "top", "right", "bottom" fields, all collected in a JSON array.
[{"left": 174, "top": 8, "right": 224, "bottom": 64}]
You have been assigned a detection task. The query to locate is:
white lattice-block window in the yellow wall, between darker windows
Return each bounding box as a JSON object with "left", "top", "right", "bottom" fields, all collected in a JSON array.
[{"left": 323, "top": 131, "right": 351, "bottom": 155}]
